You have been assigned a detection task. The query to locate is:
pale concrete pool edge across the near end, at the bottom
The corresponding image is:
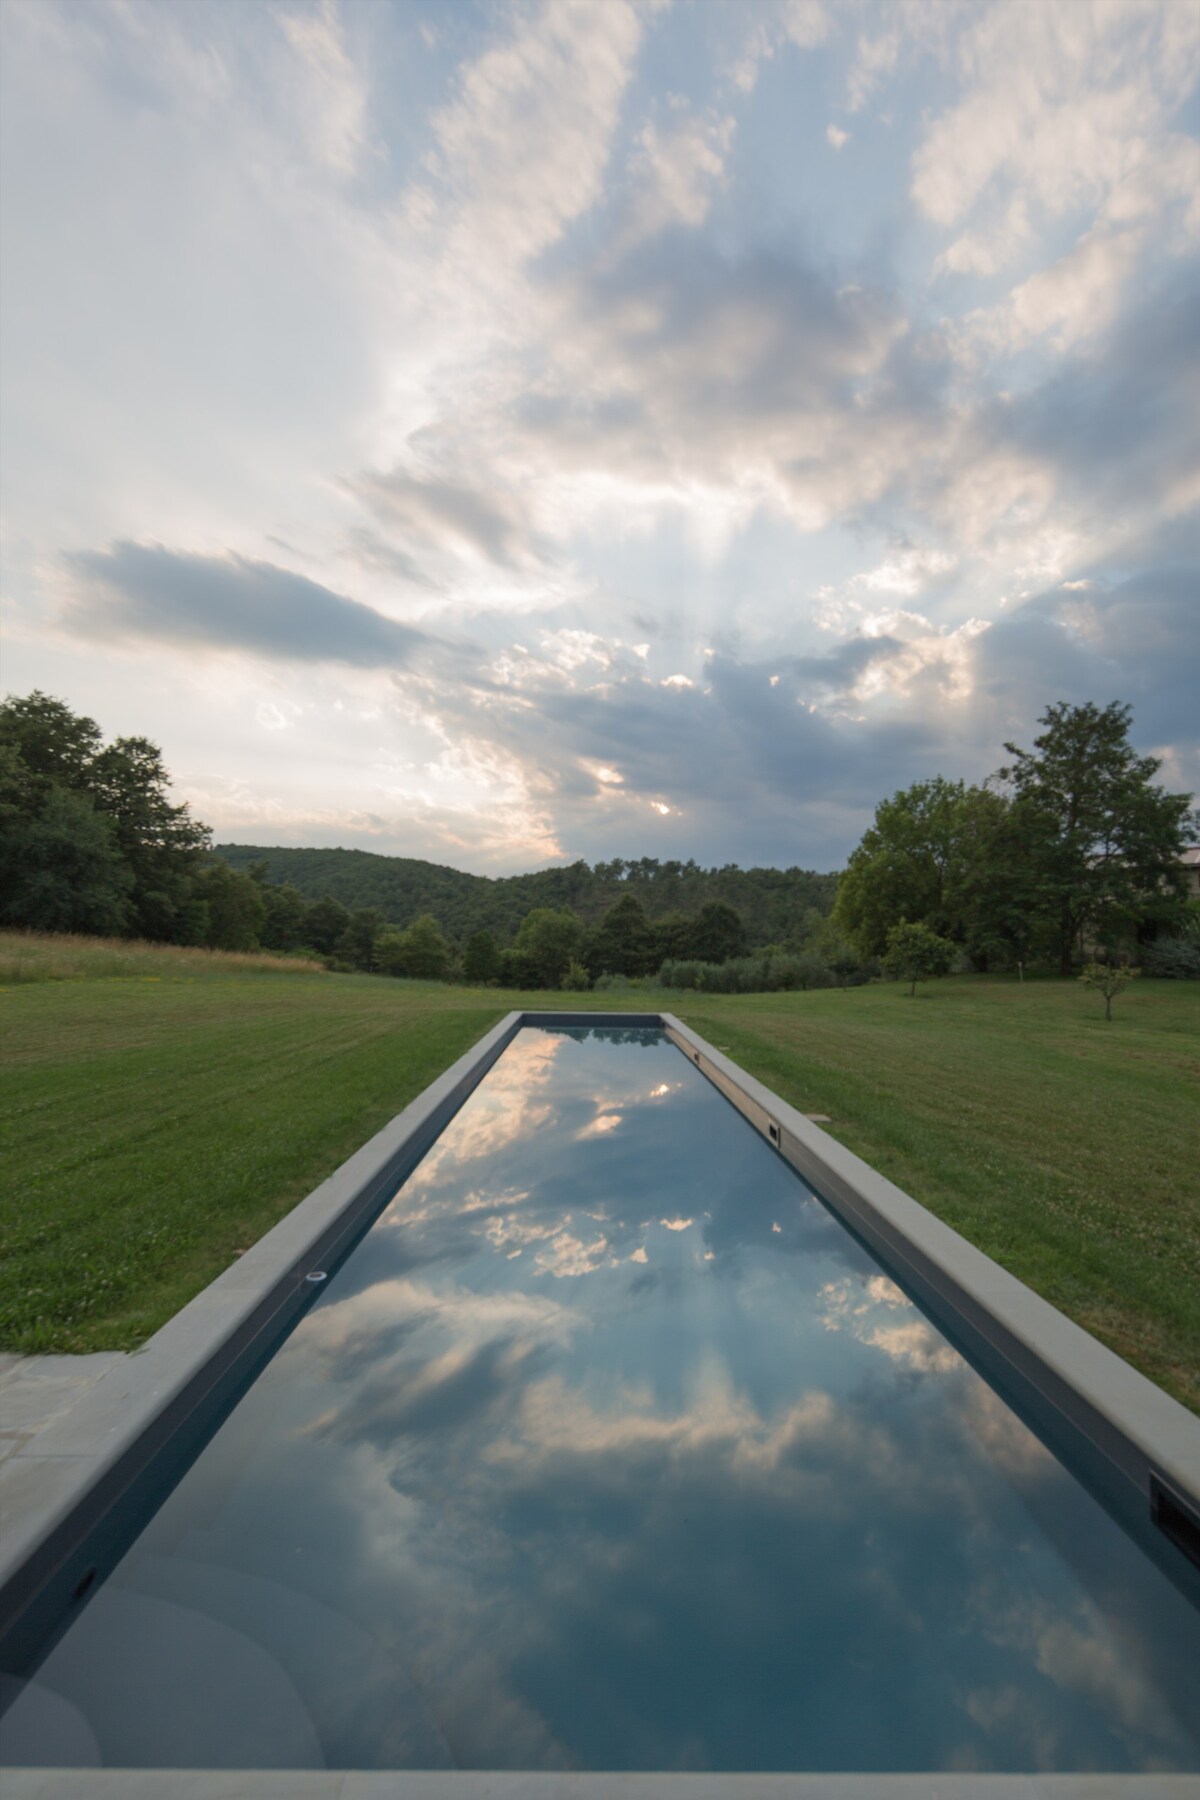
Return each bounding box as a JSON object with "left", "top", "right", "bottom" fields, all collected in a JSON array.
[{"left": 4, "top": 1769, "right": 1200, "bottom": 1800}]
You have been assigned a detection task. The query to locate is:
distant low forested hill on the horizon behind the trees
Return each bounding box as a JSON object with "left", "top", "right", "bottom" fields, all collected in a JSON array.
[{"left": 216, "top": 844, "right": 837, "bottom": 949}]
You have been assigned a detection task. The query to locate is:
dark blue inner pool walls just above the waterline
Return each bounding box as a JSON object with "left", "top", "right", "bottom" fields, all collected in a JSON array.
[{"left": 0, "top": 1012, "right": 1200, "bottom": 1681}]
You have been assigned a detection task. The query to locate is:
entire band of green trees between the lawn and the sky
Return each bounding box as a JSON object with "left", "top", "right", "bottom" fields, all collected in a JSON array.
[{"left": 0, "top": 691, "right": 1200, "bottom": 992}]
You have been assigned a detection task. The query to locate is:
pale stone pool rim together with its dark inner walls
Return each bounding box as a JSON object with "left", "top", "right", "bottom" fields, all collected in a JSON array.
[{"left": 0, "top": 1010, "right": 1200, "bottom": 1800}]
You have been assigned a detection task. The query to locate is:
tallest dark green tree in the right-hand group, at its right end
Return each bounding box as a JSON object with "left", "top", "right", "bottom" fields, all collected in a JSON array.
[{"left": 999, "top": 700, "right": 1196, "bottom": 976}]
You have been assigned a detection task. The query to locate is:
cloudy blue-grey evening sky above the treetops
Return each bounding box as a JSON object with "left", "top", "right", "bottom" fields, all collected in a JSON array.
[{"left": 0, "top": 0, "right": 1200, "bottom": 873}]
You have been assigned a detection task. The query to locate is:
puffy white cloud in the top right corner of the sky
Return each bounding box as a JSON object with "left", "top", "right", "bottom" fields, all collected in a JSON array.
[{"left": 912, "top": 0, "right": 1200, "bottom": 349}]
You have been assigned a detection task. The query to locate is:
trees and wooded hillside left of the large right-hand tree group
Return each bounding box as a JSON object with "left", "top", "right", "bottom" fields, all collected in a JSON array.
[{"left": 0, "top": 691, "right": 820, "bottom": 986}]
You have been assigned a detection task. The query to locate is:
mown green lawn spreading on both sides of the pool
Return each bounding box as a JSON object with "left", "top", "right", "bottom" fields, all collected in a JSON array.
[{"left": 0, "top": 934, "right": 1200, "bottom": 1411}]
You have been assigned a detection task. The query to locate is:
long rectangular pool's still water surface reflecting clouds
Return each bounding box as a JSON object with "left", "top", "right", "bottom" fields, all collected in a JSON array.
[{"left": 0, "top": 1028, "right": 1200, "bottom": 1771}]
